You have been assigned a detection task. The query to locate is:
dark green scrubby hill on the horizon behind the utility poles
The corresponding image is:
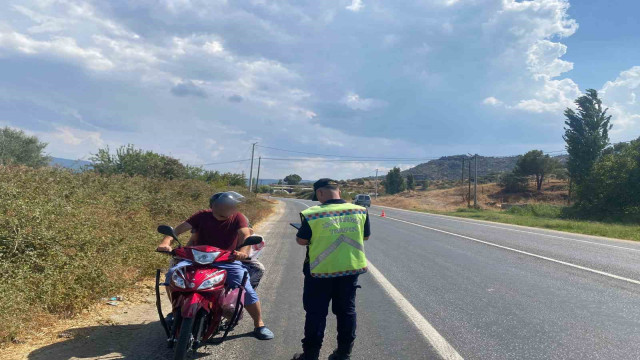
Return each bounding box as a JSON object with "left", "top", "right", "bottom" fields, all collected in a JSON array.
[{"left": 402, "top": 155, "right": 566, "bottom": 180}]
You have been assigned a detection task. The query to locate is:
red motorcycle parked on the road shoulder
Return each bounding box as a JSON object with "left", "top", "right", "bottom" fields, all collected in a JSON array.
[{"left": 155, "top": 225, "right": 263, "bottom": 360}]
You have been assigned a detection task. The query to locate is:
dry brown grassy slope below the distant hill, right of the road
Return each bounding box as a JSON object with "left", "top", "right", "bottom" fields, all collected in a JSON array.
[{"left": 373, "top": 180, "right": 567, "bottom": 211}]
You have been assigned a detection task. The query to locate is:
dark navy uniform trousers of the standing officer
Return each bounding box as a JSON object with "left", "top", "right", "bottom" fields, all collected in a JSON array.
[{"left": 302, "top": 263, "right": 360, "bottom": 353}]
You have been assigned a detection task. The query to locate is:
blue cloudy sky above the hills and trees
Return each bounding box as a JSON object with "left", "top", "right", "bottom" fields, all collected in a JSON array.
[{"left": 0, "top": 0, "right": 640, "bottom": 178}]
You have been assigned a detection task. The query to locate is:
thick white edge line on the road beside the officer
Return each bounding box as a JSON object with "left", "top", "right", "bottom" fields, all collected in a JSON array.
[{"left": 294, "top": 200, "right": 463, "bottom": 360}]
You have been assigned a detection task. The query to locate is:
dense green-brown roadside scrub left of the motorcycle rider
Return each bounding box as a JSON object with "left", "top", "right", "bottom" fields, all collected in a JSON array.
[{"left": 0, "top": 167, "right": 270, "bottom": 343}]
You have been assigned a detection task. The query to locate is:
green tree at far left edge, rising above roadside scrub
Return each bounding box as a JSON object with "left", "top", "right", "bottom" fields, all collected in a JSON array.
[{"left": 0, "top": 126, "right": 51, "bottom": 167}]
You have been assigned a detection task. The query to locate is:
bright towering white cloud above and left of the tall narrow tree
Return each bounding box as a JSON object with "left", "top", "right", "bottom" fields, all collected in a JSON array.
[{"left": 484, "top": 0, "right": 581, "bottom": 113}]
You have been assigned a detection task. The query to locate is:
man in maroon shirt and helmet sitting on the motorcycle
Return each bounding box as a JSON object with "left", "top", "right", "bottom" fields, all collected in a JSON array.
[{"left": 157, "top": 191, "right": 273, "bottom": 340}]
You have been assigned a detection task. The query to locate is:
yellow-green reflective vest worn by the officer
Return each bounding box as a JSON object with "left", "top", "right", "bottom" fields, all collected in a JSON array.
[{"left": 302, "top": 203, "right": 367, "bottom": 278}]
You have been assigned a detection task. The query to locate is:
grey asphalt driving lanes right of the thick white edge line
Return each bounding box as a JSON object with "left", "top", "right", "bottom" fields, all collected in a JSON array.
[{"left": 276, "top": 200, "right": 640, "bottom": 359}]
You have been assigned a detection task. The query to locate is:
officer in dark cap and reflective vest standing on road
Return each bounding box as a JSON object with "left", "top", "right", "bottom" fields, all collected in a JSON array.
[{"left": 293, "top": 178, "right": 371, "bottom": 360}]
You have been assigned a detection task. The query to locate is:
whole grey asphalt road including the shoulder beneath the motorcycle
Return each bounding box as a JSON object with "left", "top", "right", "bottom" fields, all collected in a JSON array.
[{"left": 28, "top": 199, "right": 640, "bottom": 360}]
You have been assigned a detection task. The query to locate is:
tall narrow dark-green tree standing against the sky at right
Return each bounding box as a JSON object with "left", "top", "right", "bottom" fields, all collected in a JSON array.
[{"left": 563, "top": 89, "right": 611, "bottom": 199}]
